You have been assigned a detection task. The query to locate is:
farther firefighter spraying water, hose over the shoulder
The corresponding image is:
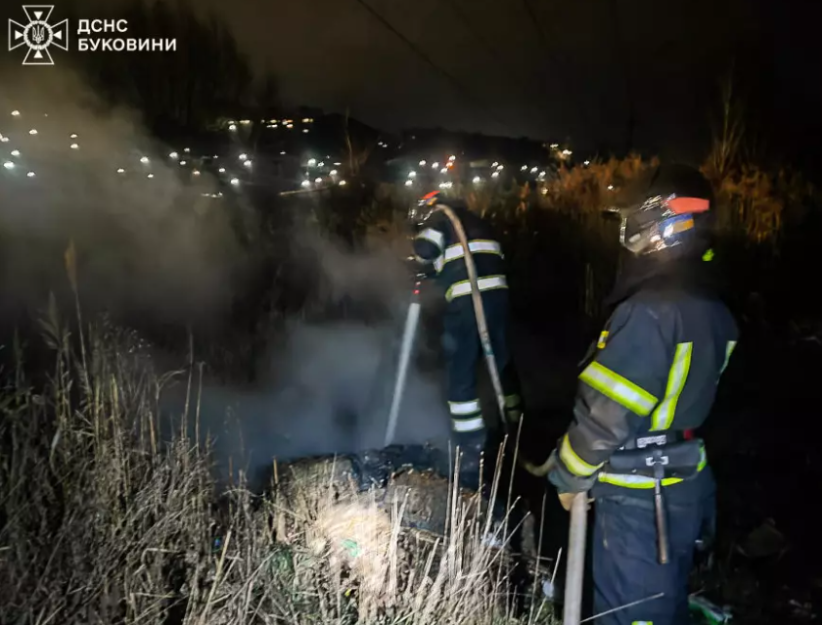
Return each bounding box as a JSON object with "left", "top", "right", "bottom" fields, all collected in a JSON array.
[{"left": 409, "top": 191, "right": 522, "bottom": 490}]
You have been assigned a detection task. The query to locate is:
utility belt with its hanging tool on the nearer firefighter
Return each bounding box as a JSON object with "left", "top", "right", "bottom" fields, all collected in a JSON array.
[{"left": 599, "top": 430, "right": 707, "bottom": 564}]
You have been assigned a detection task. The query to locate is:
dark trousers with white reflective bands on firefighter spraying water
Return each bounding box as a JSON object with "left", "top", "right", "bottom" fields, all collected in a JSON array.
[{"left": 443, "top": 289, "right": 521, "bottom": 446}]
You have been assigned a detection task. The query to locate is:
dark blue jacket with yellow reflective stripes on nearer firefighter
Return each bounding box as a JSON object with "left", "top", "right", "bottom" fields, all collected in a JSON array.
[{"left": 550, "top": 254, "right": 737, "bottom": 497}]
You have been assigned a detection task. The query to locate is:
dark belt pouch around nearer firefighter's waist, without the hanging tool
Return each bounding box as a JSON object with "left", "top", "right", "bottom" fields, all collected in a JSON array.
[{"left": 602, "top": 430, "right": 705, "bottom": 482}]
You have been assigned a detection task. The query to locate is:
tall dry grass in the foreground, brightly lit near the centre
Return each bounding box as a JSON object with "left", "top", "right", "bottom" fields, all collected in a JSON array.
[{"left": 0, "top": 294, "right": 550, "bottom": 625}]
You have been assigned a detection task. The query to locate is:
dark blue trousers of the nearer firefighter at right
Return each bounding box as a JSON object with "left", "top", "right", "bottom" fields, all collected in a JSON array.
[{"left": 592, "top": 492, "right": 715, "bottom": 625}]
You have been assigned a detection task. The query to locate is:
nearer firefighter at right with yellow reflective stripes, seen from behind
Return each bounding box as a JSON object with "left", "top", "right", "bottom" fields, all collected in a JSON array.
[{"left": 549, "top": 165, "right": 737, "bottom": 625}]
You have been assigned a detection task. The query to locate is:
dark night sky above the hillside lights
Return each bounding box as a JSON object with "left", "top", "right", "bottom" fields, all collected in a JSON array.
[{"left": 66, "top": 0, "right": 822, "bottom": 161}]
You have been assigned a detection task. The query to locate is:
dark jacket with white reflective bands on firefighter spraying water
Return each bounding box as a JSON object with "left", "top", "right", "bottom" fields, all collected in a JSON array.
[{"left": 414, "top": 206, "right": 508, "bottom": 303}]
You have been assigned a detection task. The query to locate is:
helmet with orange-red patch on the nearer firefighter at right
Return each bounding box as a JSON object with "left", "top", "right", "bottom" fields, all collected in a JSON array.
[{"left": 619, "top": 165, "right": 713, "bottom": 256}]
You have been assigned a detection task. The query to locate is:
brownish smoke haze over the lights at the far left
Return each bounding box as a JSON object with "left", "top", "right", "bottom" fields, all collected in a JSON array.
[{"left": 0, "top": 68, "right": 248, "bottom": 320}]
